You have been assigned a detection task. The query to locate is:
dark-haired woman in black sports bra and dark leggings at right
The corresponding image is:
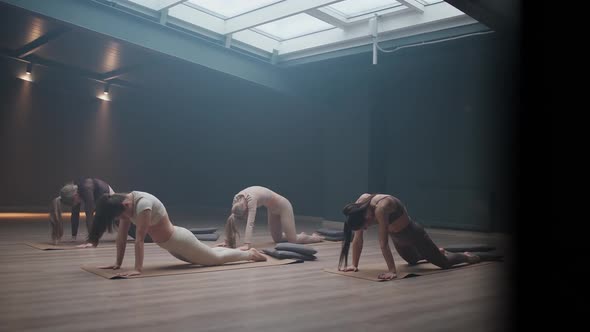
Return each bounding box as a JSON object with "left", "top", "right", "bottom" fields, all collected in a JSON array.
[{"left": 338, "top": 194, "right": 480, "bottom": 280}]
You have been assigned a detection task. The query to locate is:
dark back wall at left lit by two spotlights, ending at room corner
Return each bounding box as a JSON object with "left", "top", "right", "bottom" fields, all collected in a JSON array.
[{"left": 0, "top": 57, "right": 322, "bottom": 215}]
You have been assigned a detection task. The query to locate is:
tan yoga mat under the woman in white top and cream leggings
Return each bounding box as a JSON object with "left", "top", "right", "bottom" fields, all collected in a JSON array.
[{"left": 81, "top": 255, "right": 303, "bottom": 279}]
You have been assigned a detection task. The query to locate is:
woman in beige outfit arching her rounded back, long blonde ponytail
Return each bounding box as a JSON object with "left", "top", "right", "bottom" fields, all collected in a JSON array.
[{"left": 219, "top": 186, "right": 322, "bottom": 250}]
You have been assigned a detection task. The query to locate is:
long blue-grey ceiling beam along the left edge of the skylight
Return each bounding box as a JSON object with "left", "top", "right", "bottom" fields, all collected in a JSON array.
[{"left": 0, "top": 0, "right": 292, "bottom": 93}]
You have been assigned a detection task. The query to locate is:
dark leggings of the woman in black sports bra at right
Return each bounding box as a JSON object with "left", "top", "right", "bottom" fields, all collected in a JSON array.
[{"left": 390, "top": 221, "right": 476, "bottom": 269}]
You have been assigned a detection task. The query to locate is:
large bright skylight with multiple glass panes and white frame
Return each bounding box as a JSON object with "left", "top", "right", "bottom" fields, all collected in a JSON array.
[{"left": 108, "top": 0, "right": 480, "bottom": 63}]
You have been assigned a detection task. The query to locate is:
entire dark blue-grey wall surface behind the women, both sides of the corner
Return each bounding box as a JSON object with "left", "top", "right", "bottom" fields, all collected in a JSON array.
[{"left": 0, "top": 31, "right": 517, "bottom": 231}]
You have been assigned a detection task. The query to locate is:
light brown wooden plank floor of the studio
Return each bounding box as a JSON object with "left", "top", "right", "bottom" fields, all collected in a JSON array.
[{"left": 0, "top": 217, "right": 511, "bottom": 332}]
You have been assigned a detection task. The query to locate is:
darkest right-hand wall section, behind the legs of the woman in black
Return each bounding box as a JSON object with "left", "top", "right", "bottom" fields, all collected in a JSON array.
[{"left": 380, "top": 35, "right": 518, "bottom": 231}]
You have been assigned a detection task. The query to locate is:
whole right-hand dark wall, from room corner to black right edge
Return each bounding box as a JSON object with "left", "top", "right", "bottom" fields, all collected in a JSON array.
[{"left": 293, "top": 34, "right": 518, "bottom": 231}]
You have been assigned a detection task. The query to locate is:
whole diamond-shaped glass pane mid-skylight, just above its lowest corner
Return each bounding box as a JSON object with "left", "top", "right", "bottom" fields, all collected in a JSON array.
[{"left": 256, "top": 13, "right": 334, "bottom": 40}]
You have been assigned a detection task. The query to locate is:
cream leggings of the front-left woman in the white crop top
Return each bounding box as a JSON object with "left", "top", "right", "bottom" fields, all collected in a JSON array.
[{"left": 158, "top": 226, "right": 250, "bottom": 265}]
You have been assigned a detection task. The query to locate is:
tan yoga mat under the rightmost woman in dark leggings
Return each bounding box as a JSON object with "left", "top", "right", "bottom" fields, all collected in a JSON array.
[{"left": 324, "top": 262, "right": 492, "bottom": 282}]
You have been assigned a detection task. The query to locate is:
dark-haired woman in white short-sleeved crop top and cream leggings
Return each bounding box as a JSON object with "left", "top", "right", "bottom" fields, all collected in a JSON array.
[{"left": 88, "top": 191, "right": 266, "bottom": 276}]
